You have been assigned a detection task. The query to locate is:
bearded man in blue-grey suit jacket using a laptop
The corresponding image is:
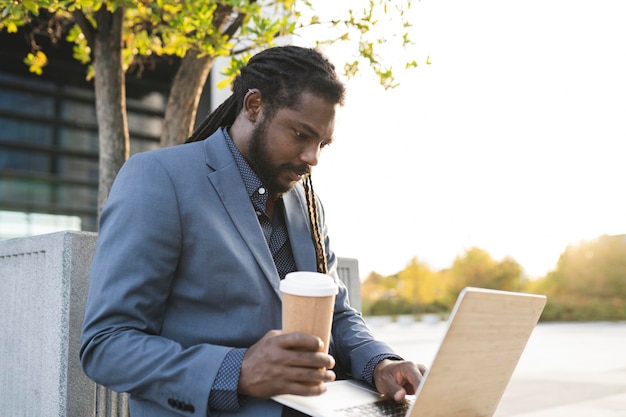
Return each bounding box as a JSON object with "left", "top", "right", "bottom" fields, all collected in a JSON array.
[{"left": 81, "top": 46, "right": 424, "bottom": 417}]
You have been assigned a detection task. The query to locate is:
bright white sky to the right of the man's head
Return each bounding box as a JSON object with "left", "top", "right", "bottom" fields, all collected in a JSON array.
[{"left": 296, "top": 0, "right": 626, "bottom": 279}]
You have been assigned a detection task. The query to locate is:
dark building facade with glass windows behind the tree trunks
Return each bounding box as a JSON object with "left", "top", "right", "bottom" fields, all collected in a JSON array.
[{"left": 0, "top": 29, "right": 211, "bottom": 239}]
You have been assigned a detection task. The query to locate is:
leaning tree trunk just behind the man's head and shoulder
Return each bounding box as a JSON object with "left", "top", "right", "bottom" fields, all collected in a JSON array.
[{"left": 161, "top": 50, "right": 213, "bottom": 147}]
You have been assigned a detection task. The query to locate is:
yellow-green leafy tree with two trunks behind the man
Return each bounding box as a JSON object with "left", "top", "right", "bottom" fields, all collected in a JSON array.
[{"left": 0, "top": 0, "right": 417, "bottom": 213}]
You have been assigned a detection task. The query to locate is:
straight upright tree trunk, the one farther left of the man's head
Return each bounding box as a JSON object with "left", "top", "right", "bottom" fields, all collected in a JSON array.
[{"left": 93, "top": 6, "right": 130, "bottom": 217}]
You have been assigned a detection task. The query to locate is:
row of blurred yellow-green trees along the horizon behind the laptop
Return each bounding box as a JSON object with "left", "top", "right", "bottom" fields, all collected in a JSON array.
[{"left": 361, "top": 235, "right": 626, "bottom": 321}]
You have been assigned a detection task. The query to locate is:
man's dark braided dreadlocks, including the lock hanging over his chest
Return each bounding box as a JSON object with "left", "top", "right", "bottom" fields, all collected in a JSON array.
[{"left": 187, "top": 45, "right": 345, "bottom": 274}]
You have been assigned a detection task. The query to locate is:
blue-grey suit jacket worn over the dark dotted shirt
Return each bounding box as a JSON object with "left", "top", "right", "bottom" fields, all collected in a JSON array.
[{"left": 81, "top": 130, "right": 393, "bottom": 417}]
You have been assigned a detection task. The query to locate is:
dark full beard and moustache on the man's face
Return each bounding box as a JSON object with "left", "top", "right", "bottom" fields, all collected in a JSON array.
[{"left": 248, "top": 119, "right": 311, "bottom": 196}]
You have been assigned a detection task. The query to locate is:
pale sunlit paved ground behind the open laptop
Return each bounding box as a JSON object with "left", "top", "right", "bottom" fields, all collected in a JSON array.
[{"left": 366, "top": 317, "right": 626, "bottom": 417}]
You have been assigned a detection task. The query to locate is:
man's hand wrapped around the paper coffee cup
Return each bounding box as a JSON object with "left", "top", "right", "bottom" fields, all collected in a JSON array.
[{"left": 238, "top": 330, "right": 335, "bottom": 398}]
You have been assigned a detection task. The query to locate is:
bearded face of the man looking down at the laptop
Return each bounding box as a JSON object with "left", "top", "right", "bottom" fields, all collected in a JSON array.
[{"left": 248, "top": 92, "right": 338, "bottom": 196}]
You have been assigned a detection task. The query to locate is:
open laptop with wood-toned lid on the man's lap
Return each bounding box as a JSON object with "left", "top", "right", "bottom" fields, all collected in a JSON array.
[{"left": 273, "top": 287, "right": 546, "bottom": 417}]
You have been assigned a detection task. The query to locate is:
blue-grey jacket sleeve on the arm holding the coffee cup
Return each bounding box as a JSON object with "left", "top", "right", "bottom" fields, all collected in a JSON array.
[{"left": 80, "top": 154, "right": 227, "bottom": 415}]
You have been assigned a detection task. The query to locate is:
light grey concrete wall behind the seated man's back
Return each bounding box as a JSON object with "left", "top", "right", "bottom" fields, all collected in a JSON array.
[{"left": 0, "top": 231, "right": 361, "bottom": 417}]
